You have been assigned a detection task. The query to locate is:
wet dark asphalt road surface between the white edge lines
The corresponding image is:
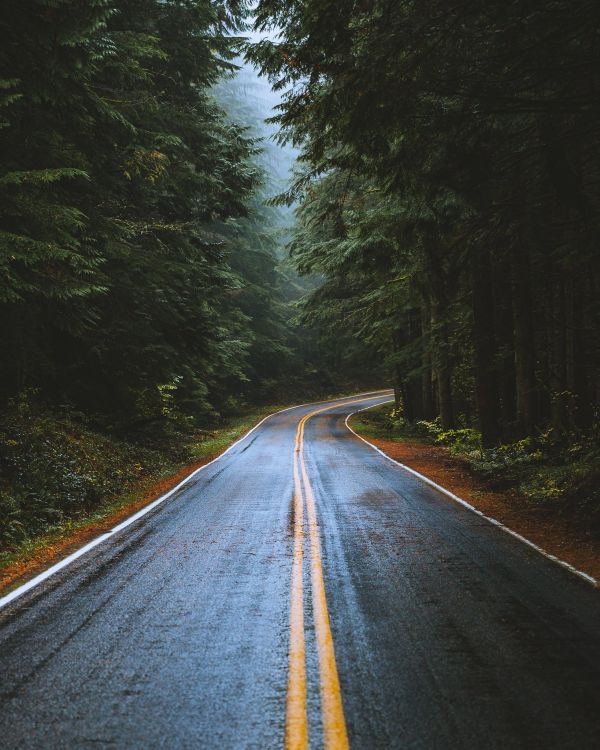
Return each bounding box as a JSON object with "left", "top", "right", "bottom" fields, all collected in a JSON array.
[{"left": 0, "top": 398, "right": 600, "bottom": 750}]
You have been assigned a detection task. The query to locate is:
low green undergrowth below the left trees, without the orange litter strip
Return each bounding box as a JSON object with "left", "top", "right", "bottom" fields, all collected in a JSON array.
[{"left": 0, "top": 396, "right": 274, "bottom": 564}]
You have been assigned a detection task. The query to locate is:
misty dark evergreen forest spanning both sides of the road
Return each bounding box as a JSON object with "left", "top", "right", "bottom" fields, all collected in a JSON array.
[{"left": 0, "top": 0, "right": 600, "bottom": 546}]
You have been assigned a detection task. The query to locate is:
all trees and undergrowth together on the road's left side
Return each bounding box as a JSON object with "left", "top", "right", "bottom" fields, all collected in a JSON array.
[{"left": 0, "top": 0, "right": 382, "bottom": 559}]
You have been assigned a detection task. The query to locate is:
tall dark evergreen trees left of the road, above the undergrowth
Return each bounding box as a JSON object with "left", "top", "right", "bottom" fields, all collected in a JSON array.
[{"left": 0, "top": 0, "right": 298, "bottom": 430}]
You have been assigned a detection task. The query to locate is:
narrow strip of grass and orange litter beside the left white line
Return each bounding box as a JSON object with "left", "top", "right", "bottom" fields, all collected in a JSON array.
[{"left": 0, "top": 405, "right": 285, "bottom": 592}]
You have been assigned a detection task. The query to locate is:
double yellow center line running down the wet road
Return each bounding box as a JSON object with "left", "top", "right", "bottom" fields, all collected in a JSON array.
[{"left": 285, "top": 396, "right": 380, "bottom": 750}]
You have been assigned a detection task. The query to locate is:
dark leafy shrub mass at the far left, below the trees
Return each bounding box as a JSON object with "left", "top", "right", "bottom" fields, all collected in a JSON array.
[{"left": 0, "top": 397, "right": 172, "bottom": 547}]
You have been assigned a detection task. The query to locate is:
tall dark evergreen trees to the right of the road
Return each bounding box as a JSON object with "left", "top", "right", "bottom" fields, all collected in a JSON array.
[{"left": 251, "top": 0, "right": 600, "bottom": 445}]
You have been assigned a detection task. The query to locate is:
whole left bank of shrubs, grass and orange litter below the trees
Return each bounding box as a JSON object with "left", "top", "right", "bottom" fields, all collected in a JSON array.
[{"left": 0, "top": 403, "right": 290, "bottom": 587}]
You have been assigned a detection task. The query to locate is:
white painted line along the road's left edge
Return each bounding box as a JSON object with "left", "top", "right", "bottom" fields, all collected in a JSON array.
[{"left": 0, "top": 388, "right": 389, "bottom": 609}]
